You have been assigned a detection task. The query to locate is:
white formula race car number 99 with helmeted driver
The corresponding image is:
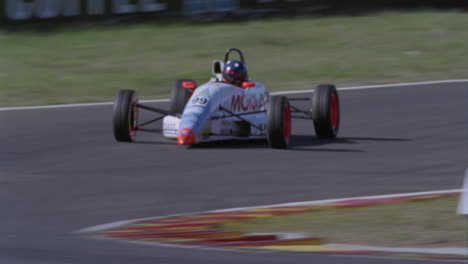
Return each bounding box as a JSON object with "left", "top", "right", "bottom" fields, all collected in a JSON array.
[{"left": 113, "top": 49, "right": 340, "bottom": 149}]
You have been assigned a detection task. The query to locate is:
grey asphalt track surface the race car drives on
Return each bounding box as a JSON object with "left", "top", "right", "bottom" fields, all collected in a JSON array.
[{"left": 0, "top": 83, "right": 468, "bottom": 264}]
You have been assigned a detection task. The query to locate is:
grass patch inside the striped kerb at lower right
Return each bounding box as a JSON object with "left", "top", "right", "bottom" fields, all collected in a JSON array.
[{"left": 223, "top": 196, "right": 468, "bottom": 247}]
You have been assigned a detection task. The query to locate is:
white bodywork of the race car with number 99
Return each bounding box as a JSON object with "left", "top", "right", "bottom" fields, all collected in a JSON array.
[{"left": 163, "top": 79, "right": 269, "bottom": 142}]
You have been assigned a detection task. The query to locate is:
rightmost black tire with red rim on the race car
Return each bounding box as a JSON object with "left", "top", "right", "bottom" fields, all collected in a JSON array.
[{"left": 312, "top": 84, "right": 340, "bottom": 139}]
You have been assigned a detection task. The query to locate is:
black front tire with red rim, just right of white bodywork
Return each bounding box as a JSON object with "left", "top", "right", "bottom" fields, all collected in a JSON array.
[{"left": 267, "top": 96, "right": 291, "bottom": 149}]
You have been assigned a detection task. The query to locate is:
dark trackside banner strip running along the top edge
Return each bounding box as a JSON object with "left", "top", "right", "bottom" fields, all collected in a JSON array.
[{"left": 0, "top": 0, "right": 468, "bottom": 25}]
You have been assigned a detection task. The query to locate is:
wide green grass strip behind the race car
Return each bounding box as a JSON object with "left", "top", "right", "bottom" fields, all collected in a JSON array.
[{"left": 0, "top": 11, "right": 468, "bottom": 106}]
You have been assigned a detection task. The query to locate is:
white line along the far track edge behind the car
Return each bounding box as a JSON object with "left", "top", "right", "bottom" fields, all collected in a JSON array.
[{"left": 0, "top": 79, "right": 468, "bottom": 112}]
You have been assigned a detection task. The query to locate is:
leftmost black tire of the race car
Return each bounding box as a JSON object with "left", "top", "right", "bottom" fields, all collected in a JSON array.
[{"left": 112, "top": 90, "right": 138, "bottom": 142}]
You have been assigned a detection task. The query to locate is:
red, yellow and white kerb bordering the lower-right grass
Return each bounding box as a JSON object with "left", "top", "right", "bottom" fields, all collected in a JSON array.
[{"left": 76, "top": 189, "right": 468, "bottom": 260}]
